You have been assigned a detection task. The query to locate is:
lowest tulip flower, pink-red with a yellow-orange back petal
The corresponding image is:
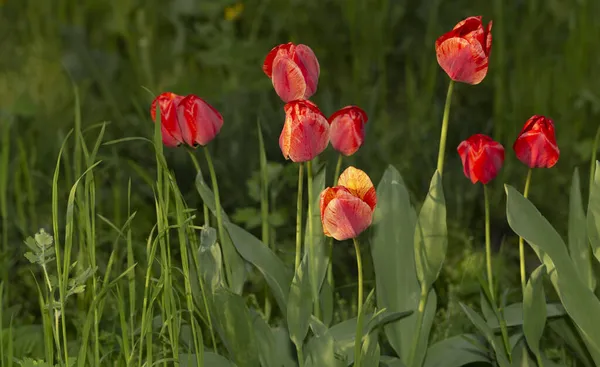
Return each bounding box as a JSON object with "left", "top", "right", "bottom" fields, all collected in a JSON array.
[{"left": 319, "top": 166, "right": 377, "bottom": 241}]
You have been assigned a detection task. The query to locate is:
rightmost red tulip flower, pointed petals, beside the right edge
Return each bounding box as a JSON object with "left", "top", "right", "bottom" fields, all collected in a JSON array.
[{"left": 513, "top": 115, "right": 560, "bottom": 168}]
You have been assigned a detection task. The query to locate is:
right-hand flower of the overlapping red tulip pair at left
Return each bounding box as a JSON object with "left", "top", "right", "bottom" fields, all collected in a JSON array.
[{"left": 177, "top": 94, "right": 223, "bottom": 146}]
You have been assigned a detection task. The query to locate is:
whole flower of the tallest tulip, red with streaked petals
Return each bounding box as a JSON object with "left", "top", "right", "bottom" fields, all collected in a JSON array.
[{"left": 435, "top": 16, "right": 492, "bottom": 84}]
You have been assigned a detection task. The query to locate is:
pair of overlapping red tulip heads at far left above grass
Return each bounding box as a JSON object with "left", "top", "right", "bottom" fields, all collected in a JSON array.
[{"left": 150, "top": 92, "right": 223, "bottom": 147}]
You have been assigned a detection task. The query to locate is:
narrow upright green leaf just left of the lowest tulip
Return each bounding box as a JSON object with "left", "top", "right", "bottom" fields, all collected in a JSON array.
[{"left": 304, "top": 166, "right": 328, "bottom": 310}]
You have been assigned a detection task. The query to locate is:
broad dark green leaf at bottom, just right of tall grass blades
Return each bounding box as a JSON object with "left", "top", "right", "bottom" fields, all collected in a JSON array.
[{"left": 212, "top": 288, "right": 259, "bottom": 367}]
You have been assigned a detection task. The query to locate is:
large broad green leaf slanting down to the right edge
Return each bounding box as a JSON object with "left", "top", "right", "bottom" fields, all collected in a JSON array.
[{"left": 506, "top": 186, "right": 600, "bottom": 353}]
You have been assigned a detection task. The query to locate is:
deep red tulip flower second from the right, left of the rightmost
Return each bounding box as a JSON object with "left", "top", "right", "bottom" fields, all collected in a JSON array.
[{"left": 458, "top": 134, "right": 504, "bottom": 185}]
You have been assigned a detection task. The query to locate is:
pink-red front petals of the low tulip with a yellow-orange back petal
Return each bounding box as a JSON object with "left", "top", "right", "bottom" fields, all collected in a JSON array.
[{"left": 322, "top": 191, "right": 373, "bottom": 241}]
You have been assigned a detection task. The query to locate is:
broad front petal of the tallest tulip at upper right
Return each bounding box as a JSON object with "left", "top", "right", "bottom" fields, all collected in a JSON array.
[{"left": 436, "top": 37, "right": 488, "bottom": 84}]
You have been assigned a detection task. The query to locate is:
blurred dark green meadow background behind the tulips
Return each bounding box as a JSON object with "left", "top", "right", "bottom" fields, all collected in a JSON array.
[{"left": 0, "top": 0, "right": 600, "bottom": 342}]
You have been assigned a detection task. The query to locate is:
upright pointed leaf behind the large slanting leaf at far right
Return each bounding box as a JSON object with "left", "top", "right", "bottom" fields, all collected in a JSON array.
[{"left": 569, "top": 168, "right": 598, "bottom": 291}]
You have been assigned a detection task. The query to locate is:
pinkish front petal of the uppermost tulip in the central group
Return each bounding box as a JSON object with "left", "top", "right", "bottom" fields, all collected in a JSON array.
[{"left": 271, "top": 55, "right": 306, "bottom": 102}]
